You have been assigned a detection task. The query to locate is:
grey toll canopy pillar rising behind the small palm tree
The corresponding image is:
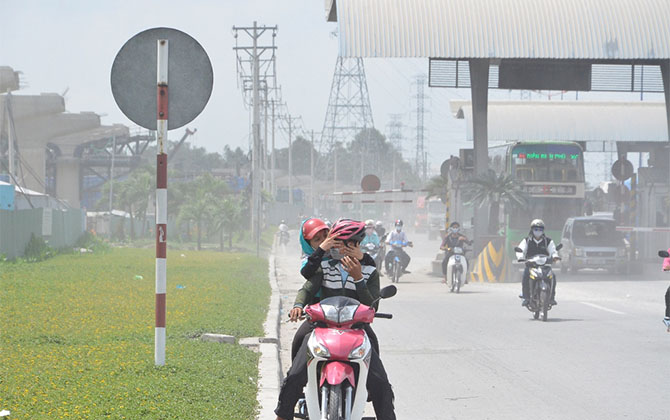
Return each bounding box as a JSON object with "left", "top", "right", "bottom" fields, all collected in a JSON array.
[{"left": 469, "top": 58, "right": 489, "bottom": 252}]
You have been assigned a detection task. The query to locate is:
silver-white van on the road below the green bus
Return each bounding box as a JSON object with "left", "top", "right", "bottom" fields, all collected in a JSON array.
[{"left": 559, "top": 216, "right": 629, "bottom": 273}]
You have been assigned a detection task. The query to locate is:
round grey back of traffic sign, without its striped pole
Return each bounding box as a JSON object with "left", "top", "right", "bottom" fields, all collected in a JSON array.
[{"left": 110, "top": 28, "right": 214, "bottom": 130}]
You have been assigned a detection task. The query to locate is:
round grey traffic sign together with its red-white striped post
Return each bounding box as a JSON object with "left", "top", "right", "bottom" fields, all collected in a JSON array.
[{"left": 111, "top": 28, "right": 214, "bottom": 366}]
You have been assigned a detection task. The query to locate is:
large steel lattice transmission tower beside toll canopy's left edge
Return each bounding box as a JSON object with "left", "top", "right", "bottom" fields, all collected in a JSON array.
[{"left": 319, "top": 57, "right": 374, "bottom": 190}]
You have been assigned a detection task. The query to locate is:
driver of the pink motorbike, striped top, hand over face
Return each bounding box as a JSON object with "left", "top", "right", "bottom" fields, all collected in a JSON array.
[{"left": 275, "top": 219, "right": 396, "bottom": 420}]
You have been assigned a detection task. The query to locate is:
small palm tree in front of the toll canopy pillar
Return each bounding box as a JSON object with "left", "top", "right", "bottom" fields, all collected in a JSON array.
[{"left": 468, "top": 170, "right": 528, "bottom": 235}]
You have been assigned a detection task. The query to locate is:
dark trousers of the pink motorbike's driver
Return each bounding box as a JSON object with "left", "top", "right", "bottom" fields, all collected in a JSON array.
[{"left": 275, "top": 326, "right": 395, "bottom": 420}]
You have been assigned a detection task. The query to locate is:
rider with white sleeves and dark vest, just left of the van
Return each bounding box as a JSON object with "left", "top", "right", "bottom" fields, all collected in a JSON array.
[{"left": 516, "top": 219, "right": 559, "bottom": 306}]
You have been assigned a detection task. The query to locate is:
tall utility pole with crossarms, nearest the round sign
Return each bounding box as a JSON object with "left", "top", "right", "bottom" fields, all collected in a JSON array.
[{"left": 233, "top": 21, "right": 277, "bottom": 255}]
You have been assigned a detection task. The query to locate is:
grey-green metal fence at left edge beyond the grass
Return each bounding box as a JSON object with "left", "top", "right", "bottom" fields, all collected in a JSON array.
[{"left": 0, "top": 208, "right": 85, "bottom": 258}]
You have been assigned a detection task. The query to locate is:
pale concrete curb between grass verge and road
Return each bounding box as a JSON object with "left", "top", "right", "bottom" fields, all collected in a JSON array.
[{"left": 256, "top": 246, "right": 282, "bottom": 420}]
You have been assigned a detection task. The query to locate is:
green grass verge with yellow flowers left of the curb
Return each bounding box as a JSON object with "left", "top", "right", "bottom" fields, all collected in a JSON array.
[{"left": 0, "top": 249, "right": 270, "bottom": 419}]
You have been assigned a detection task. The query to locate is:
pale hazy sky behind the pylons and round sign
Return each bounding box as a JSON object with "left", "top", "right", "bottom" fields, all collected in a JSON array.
[{"left": 0, "top": 0, "right": 662, "bottom": 177}]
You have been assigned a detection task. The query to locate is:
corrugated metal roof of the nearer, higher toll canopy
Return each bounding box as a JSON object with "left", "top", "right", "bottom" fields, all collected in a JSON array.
[{"left": 334, "top": 0, "right": 670, "bottom": 59}]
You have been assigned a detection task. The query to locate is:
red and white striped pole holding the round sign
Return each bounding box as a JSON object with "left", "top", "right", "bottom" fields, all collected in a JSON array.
[{"left": 154, "top": 39, "right": 168, "bottom": 366}]
